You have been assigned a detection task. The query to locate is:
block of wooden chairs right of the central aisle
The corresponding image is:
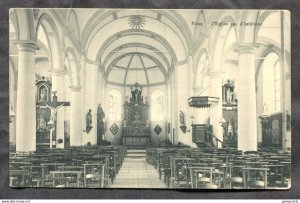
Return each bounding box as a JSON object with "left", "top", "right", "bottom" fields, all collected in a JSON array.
[{"left": 146, "top": 146, "right": 291, "bottom": 189}]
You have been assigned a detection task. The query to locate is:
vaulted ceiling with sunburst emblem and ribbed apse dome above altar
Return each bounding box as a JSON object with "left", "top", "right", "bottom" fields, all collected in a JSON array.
[{"left": 57, "top": 9, "right": 199, "bottom": 86}]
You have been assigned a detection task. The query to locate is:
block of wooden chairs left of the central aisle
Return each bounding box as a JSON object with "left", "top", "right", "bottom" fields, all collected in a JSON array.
[{"left": 9, "top": 146, "right": 127, "bottom": 188}]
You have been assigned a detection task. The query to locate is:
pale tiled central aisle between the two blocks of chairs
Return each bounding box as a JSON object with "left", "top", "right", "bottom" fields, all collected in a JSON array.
[{"left": 111, "top": 157, "right": 166, "bottom": 188}]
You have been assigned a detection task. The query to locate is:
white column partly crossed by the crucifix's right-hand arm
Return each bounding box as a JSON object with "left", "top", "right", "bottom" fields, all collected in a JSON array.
[{"left": 51, "top": 69, "right": 65, "bottom": 149}]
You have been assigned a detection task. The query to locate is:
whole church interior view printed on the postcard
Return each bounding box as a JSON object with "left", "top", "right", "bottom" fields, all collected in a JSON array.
[{"left": 9, "top": 8, "right": 291, "bottom": 189}]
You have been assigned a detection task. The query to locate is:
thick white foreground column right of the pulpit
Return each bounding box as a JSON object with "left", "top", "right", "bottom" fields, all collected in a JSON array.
[{"left": 237, "top": 44, "right": 257, "bottom": 151}]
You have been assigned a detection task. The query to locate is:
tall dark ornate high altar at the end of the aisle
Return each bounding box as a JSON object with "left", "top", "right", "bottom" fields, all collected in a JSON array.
[{"left": 122, "top": 83, "right": 151, "bottom": 146}]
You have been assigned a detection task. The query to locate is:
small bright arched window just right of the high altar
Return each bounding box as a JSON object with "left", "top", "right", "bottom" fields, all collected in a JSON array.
[{"left": 151, "top": 91, "right": 164, "bottom": 121}]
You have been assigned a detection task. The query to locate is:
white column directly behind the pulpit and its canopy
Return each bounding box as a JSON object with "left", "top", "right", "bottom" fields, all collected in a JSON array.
[{"left": 210, "top": 72, "right": 223, "bottom": 148}]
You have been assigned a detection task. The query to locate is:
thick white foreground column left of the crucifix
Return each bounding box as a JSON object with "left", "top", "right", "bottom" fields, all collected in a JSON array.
[{"left": 16, "top": 41, "right": 37, "bottom": 152}]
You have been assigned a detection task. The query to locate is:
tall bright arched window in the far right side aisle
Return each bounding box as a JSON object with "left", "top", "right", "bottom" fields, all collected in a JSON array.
[{"left": 261, "top": 52, "right": 281, "bottom": 113}]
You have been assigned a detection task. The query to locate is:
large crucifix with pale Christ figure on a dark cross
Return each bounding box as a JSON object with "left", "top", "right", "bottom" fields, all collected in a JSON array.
[{"left": 46, "top": 91, "right": 70, "bottom": 148}]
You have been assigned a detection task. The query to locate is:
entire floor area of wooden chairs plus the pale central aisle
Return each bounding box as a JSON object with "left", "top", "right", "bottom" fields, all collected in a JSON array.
[{"left": 10, "top": 146, "right": 291, "bottom": 189}]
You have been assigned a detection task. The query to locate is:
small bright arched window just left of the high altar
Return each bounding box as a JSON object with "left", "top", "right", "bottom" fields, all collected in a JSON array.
[{"left": 108, "top": 90, "right": 121, "bottom": 121}]
